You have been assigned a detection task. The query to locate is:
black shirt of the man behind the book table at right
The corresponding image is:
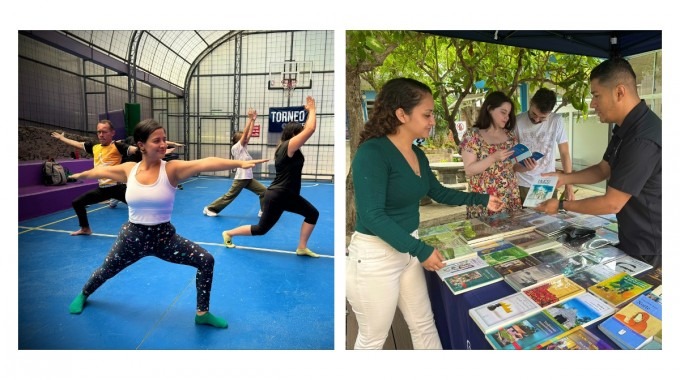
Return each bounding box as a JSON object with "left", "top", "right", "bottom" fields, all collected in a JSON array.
[{"left": 603, "top": 101, "right": 661, "bottom": 256}]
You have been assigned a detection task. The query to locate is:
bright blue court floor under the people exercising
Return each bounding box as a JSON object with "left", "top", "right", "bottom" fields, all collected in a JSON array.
[{"left": 18, "top": 176, "right": 335, "bottom": 350}]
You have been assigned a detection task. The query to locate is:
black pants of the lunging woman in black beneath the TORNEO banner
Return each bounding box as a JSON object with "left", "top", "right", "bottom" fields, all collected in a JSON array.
[{"left": 250, "top": 189, "right": 319, "bottom": 236}]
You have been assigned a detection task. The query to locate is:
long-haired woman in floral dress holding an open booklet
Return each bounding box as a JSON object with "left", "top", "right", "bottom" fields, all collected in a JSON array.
[{"left": 460, "top": 91, "right": 522, "bottom": 218}]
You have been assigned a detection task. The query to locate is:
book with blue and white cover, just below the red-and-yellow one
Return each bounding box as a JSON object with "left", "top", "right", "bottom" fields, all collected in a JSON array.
[{"left": 545, "top": 293, "right": 616, "bottom": 330}]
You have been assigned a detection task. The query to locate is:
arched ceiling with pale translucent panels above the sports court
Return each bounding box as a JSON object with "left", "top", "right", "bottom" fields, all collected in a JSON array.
[{"left": 21, "top": 30, "right": 240, "bottom": 95}]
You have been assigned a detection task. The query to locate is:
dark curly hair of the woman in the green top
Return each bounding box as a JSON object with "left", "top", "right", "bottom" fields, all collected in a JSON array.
[{"left": 359, "top": 78, "right": 432, "bottom": 145}]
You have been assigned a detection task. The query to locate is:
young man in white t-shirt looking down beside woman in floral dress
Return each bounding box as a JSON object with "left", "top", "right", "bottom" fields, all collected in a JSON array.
[{"left": 514, "top": 88, "right": 574, "bottom": 202}]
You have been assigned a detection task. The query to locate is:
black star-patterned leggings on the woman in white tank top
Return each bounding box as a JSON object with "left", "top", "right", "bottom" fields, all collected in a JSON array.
[{"left": 83, "top": 222, "right": 215, "bottom": 311}]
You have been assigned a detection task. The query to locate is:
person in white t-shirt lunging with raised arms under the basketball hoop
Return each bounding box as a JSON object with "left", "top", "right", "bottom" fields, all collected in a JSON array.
[{"left": 203, "top": 108, "right": 267, "bottom": 217}]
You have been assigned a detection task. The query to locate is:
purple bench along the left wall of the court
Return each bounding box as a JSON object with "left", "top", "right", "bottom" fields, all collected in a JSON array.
[{"left": 18, "top": 159, "right": 99, "bottom": 221}]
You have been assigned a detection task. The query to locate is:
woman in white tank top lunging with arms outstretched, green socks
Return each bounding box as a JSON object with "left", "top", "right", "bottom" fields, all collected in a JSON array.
[{"left": 69, "top": 119, "right": 268, "bottom": 328}]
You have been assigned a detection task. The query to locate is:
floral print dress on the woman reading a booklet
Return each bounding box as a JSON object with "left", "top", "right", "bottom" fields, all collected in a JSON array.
[{"left": 460, "top": 128, "right": 522, "bottom": 218}]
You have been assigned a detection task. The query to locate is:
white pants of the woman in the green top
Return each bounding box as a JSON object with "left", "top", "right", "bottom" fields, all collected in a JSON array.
[{"left": 345, "top": 232, "right": 442, "bottom": 350}]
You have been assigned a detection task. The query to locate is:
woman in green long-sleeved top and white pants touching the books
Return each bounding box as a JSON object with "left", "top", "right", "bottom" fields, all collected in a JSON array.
[{"left": 346, "top": 78, "right": 503, "bottom": 349}]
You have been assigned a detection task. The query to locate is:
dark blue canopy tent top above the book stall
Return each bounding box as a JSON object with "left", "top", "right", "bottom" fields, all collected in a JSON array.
[{"left": 423, "top": 30, "right": 661, "bottom": 58}]
